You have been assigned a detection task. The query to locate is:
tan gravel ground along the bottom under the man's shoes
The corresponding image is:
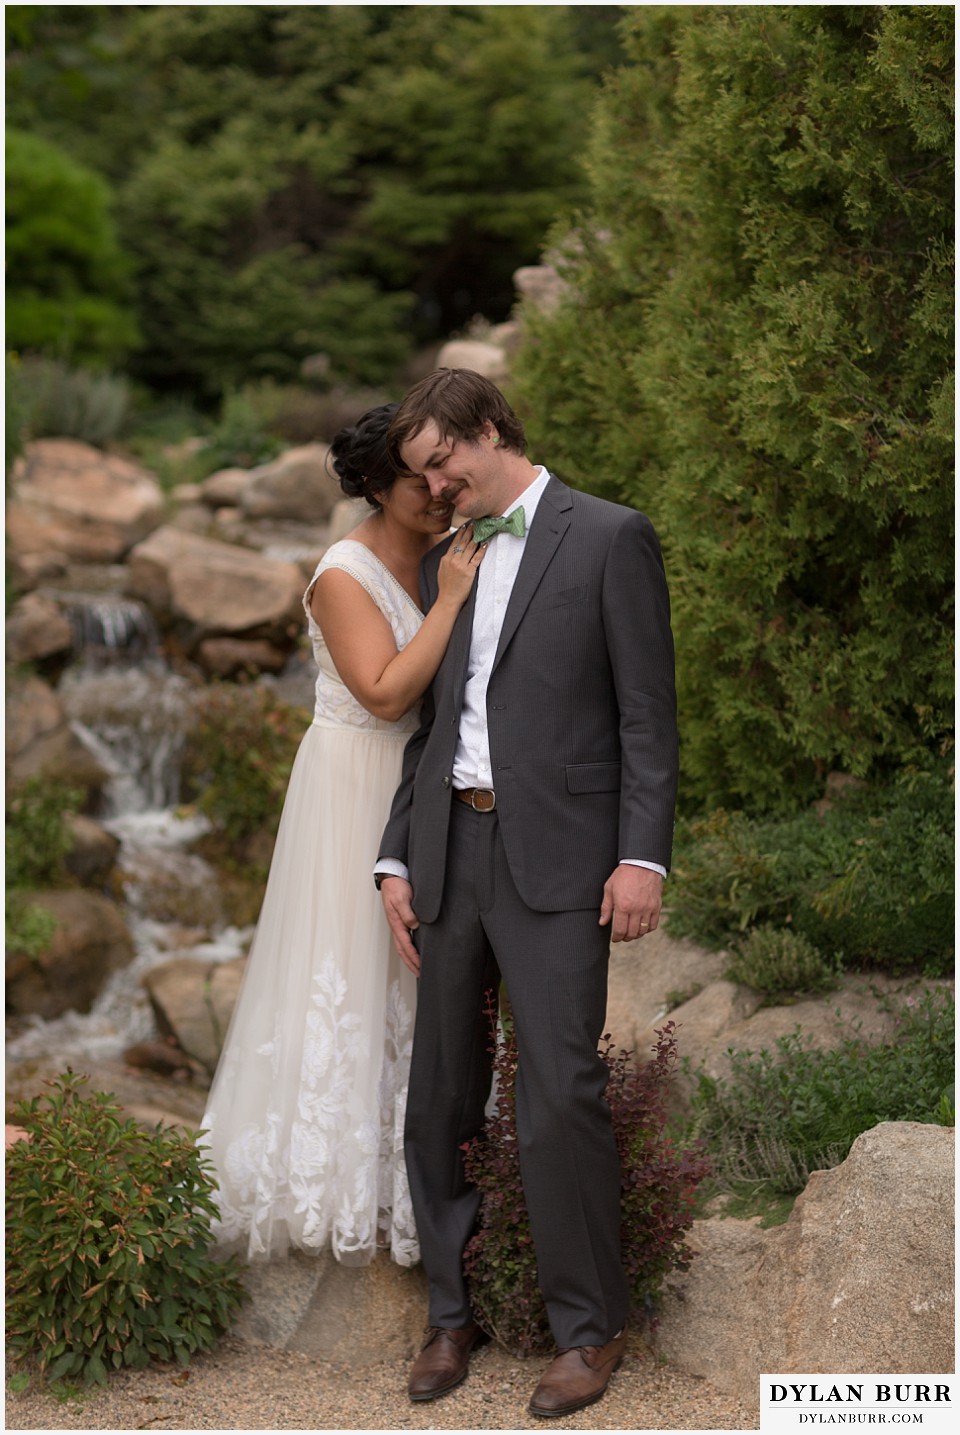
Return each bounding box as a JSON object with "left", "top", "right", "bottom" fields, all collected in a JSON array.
[{"left": 6, "top": 1335, "right": 759, "bottom": 1431}]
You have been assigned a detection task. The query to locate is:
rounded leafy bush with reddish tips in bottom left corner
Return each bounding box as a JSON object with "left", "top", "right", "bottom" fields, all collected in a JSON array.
[{"left": 6, "top": 1072, "right": 245, "bottom": 1385}]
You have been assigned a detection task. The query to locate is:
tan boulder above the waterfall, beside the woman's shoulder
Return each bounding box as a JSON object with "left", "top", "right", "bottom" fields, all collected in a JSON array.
[{"left": 128, "top": 524, "right": 303, "bottom": 640}]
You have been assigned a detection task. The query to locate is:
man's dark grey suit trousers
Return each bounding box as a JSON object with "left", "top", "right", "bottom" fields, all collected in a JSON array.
[{"left": 405, "top": 801, "right": 629, "bottom": 1349}]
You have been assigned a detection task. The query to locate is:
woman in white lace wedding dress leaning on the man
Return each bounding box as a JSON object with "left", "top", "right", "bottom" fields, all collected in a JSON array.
[{"left": 199, "top": 405, "right": 484, "bottom": 1266}]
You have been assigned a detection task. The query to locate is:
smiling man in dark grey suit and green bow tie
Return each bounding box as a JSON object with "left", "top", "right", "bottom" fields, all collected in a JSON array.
[{"left": 376, "top": 369, "right": 677, "bottom": 1416}]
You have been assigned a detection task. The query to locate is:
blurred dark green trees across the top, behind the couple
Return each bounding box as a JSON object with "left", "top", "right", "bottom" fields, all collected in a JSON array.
[{"left": 7, "top": 4, "right": 620, "bottom": 396}]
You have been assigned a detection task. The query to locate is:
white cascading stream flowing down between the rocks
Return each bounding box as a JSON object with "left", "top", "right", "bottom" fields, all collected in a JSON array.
[{"left": 7, "top": 594, "right": 258, "bottom": 1066}]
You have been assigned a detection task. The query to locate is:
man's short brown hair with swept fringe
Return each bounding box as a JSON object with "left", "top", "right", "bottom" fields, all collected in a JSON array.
[{"left": 386, "top": 369, "right": 527, "bottom": 469}]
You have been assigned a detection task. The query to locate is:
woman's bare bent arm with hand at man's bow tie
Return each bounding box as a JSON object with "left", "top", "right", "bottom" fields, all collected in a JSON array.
[{"left": 310, "top": 542, "right": 484, "bottom": 722}]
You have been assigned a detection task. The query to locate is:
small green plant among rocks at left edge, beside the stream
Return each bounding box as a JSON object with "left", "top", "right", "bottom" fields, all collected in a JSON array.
[{"left": 4, "top": 778, "right": 83, "bottom": 956}]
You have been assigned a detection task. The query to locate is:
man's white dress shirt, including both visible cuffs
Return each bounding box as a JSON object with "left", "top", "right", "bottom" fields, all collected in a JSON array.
[{"left": 376, "top": 466, "right": 667, "bottom": 877}]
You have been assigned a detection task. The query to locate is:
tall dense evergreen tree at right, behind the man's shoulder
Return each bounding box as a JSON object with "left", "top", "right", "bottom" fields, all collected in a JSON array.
[{"left": 517, "top": 6, "right": 953, "bottom": 808}]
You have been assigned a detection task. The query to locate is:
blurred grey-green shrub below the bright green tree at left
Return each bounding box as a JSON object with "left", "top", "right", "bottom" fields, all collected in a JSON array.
[{"left": 20, "top": 359, "right": 131, "bottom": 448}]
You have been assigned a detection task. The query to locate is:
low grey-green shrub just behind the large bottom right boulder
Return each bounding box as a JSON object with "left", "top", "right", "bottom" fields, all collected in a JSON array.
[{"left": 687, "top": 992, "right": 954, "bottom": 1192}]
